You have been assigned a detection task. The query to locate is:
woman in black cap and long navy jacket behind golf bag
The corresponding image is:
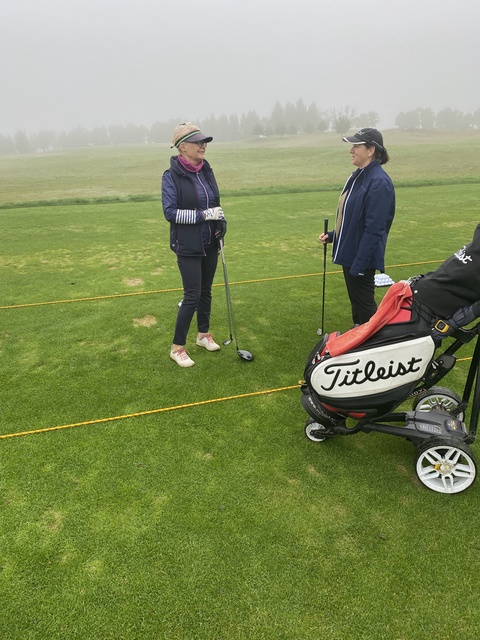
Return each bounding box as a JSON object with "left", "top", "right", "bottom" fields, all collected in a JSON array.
[{"left": 319, "top": 128, "right": 395, "bottom": 324}]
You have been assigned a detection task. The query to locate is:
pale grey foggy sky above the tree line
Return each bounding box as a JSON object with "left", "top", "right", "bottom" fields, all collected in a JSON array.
[{"left": 0, "top": 0, "right": 480, "bottom": 135}]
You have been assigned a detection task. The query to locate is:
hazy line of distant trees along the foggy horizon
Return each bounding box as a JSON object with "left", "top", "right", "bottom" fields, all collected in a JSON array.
[{"left": 0, "top": 99, "right": 480, "bottom": 154}]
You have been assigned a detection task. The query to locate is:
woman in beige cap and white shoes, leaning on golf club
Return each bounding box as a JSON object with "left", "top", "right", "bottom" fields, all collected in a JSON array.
[{"left": 162, "top": 122, "right": 227, "bottom": 367}]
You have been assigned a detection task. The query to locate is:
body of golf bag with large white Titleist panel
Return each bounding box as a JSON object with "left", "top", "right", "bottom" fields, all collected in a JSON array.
[{"left": 302, "top": 297, "right": 440, "bottom": 428}]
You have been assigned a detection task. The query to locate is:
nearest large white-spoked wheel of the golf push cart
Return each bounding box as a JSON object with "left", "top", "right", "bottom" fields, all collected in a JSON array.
[{"left": 415, "top": 438, "right": 477, "bottom": 493}]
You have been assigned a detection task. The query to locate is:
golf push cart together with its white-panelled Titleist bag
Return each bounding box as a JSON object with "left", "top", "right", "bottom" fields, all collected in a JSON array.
[{"left": 301, "top": 292, "right": 480, "bottom": 493}]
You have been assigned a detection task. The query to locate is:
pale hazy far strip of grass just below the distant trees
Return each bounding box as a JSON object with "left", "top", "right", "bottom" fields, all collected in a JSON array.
[{"left": 0, "top": 126, "right": 480, "bottom": 206}]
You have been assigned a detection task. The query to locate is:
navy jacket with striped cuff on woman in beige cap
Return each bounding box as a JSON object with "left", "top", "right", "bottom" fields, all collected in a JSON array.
[{"left": 162, "top": 156, "right": 220, "bottom": 256}]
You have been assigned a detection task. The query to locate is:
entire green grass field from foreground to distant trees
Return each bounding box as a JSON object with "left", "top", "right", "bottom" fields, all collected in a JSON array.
[{"left": 0, "top": 131, "right": 480, "bottom": 640}]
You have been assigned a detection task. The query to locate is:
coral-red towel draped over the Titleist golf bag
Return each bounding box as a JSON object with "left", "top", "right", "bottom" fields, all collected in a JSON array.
[{"left": 327, "top": 281, "right": 412, "bottom": 356}]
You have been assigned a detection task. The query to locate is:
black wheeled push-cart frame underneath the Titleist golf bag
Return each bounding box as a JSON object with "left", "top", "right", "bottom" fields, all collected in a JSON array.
[{"left": 301, "top": 322, "right": 480, "bottom": 493}]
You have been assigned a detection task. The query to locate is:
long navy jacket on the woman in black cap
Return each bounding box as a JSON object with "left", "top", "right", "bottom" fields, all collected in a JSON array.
[{"left": 329, "top": 160, "right": 395, "bottom": 276}]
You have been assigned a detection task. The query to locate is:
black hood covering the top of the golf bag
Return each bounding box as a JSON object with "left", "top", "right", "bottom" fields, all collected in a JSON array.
[{"left": 409, "top": 224, "right": 480, "bottom": 341}]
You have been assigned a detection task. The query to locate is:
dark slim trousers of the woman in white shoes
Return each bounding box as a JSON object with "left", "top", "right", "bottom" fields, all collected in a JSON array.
[{"left": 173, "top": 247, "right": 218, "bottom": 346}]
